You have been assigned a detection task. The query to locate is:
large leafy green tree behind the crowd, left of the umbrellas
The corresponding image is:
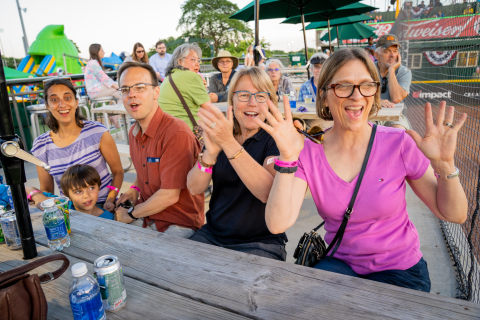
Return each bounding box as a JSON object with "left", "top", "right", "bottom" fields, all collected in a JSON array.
[{"left": 177, "top": 0, "right": 252, "bottom": 55}]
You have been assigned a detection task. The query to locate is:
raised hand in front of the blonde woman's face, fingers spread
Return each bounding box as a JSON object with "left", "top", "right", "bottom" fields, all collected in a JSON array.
[{"left": 253, "top": 95, "right": 305, "bottom": 161}]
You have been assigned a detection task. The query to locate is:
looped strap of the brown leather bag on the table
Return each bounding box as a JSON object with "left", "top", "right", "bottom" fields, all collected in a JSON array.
[{"left": 0, "top": 254, "right": 70, "bottom": 283}]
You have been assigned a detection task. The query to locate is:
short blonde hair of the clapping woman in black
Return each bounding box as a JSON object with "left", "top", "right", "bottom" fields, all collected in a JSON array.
[{"left": 228, "top": 67, "right": 278, "bottom": 136}]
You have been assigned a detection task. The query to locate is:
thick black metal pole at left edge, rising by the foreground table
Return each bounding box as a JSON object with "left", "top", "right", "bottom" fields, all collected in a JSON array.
[{"left": 0, "top": 50, "right": 37, "bottom": 259}]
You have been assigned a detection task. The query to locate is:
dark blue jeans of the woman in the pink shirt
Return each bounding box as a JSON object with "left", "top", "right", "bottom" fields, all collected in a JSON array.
[{"left": 314, "top": 258, "right": 430, "bottom": 292}]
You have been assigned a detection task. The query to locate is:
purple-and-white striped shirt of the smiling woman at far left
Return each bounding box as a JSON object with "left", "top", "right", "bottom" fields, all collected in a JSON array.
[{"left": 31, "top": 121, "right": 112, "bottom": 203}]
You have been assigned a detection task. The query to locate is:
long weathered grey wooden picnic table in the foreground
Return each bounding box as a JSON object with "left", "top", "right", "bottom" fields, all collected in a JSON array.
[{"left": 0, "top": 210, "right": 480, "bottom": 320}]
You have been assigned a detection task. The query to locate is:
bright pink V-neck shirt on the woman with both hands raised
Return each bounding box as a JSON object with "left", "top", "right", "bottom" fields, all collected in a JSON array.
[{"left": 295, "top": 126, "right": 429, "bottom": 274}]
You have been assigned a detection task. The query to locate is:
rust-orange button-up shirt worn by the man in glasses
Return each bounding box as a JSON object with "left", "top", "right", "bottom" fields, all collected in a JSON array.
[{"left": 129, "top": 107, "right": 205, "bottom": 232}]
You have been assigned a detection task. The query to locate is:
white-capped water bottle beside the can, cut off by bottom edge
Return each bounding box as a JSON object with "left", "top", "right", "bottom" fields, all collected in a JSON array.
[{"left": 68, "top": 262, "right": 107, "bottom": 320}]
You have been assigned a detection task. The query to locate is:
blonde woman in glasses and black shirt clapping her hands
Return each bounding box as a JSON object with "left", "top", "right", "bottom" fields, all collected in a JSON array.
[{"left": 187, "top": 67, "right": 287, "bottom": 261}]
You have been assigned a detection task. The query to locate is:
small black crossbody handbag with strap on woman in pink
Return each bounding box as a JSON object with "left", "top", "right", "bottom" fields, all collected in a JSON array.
[{"left": 293, "top": 124, "right": 377, "bottom": 267}]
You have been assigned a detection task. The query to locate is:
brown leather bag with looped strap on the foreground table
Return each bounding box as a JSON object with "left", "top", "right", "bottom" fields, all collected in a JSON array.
[{"left": 0, "top": 254, "right": 70, "bottom": 320}]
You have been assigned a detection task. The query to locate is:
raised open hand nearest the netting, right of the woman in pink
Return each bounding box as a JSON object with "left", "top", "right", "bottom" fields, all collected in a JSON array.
[{"left": 406, "top": 101, "right": 467, "bottom": 165}]
